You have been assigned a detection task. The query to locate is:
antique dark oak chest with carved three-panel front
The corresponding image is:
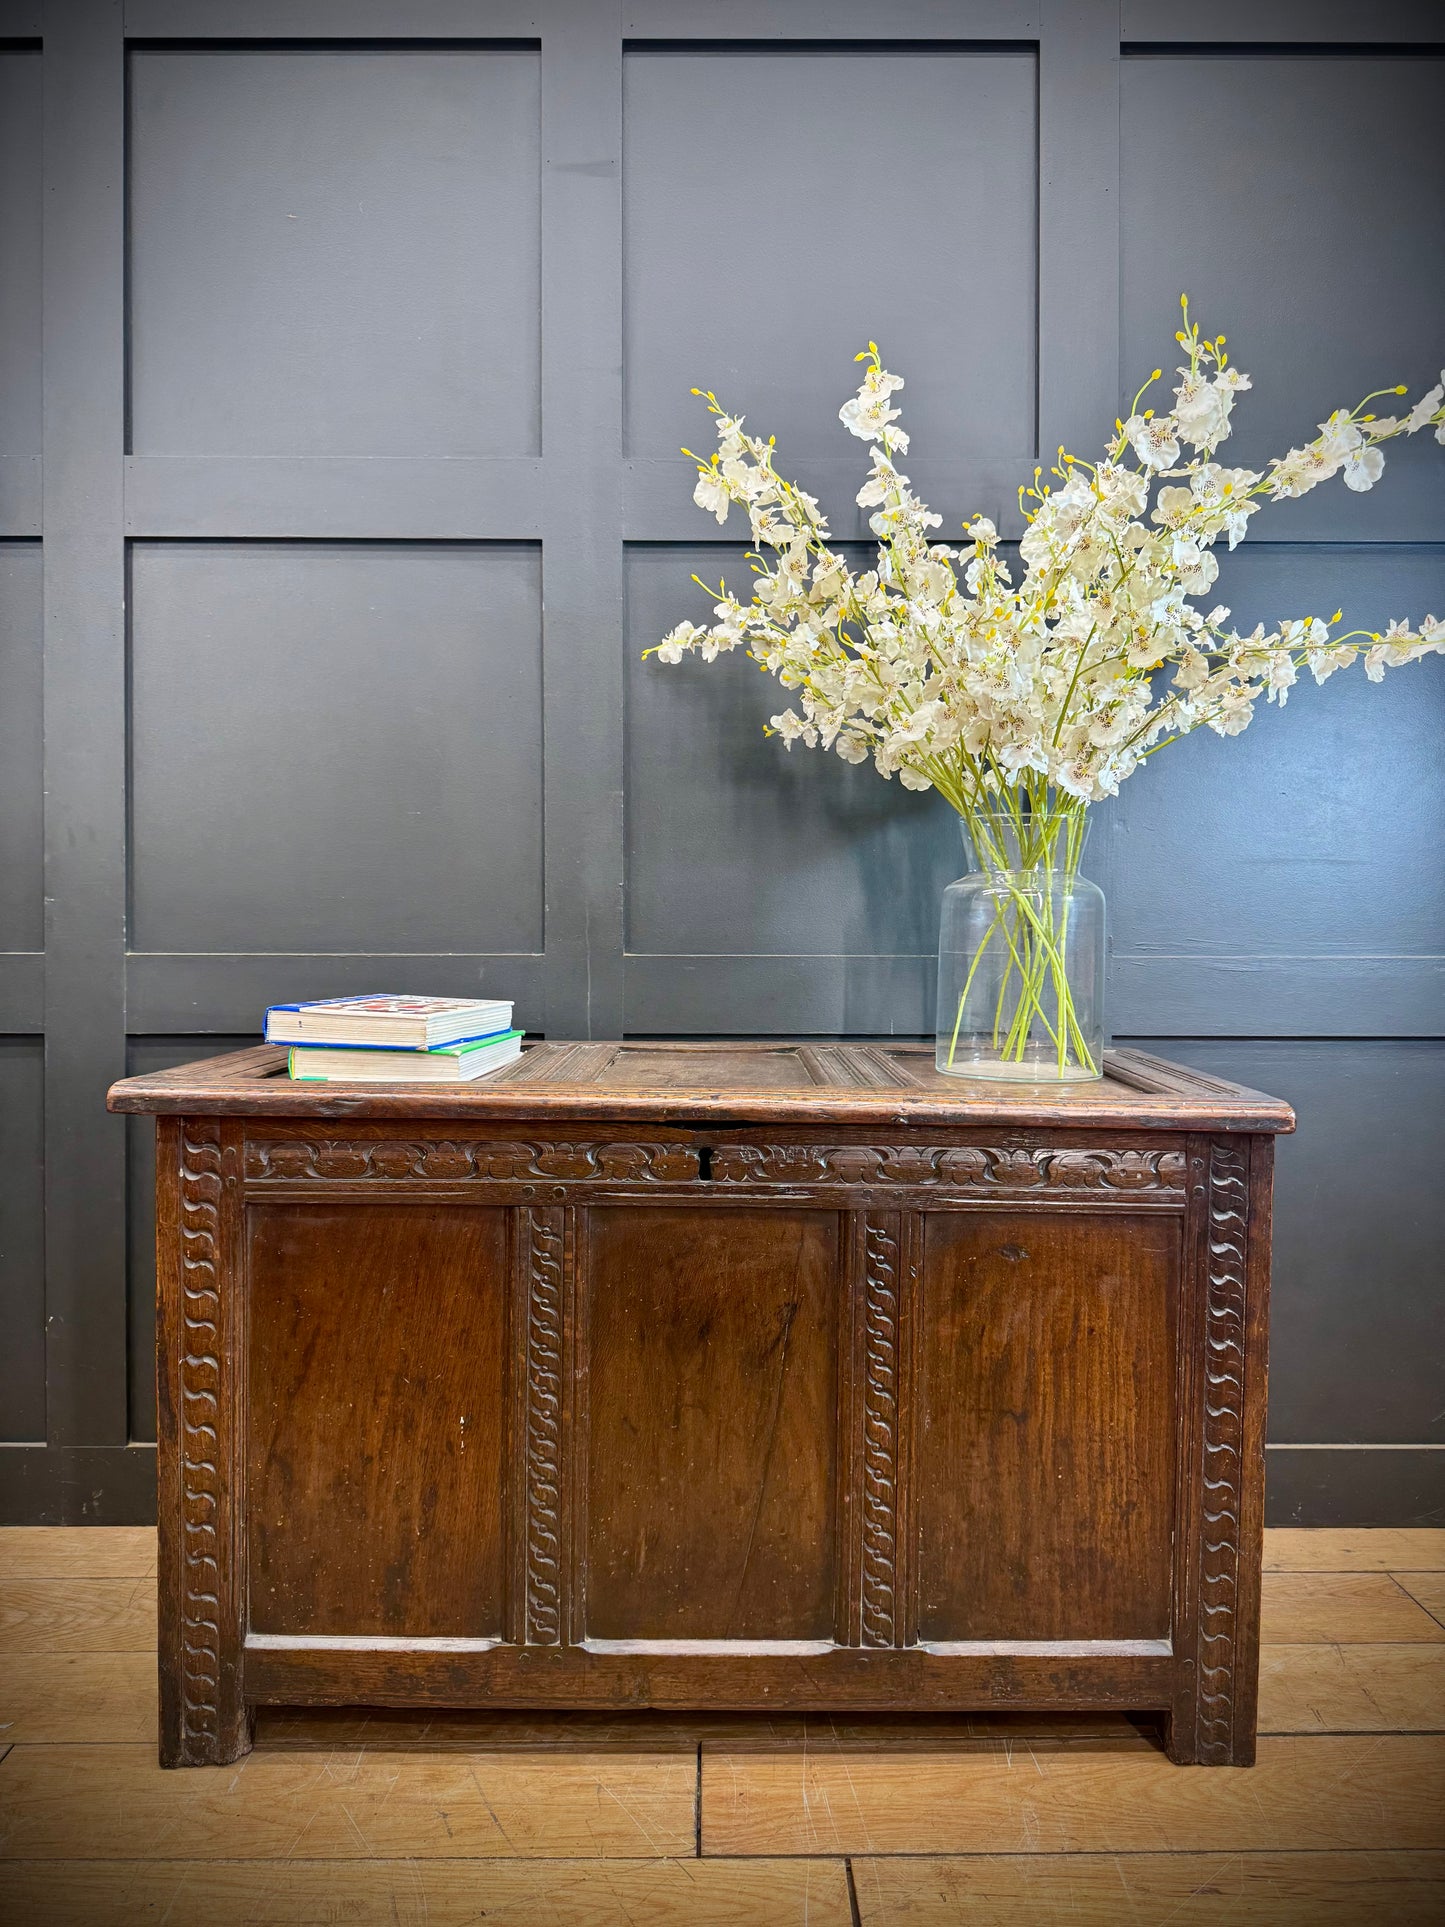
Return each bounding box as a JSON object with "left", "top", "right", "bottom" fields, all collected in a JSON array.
[{"left": 110, "top": 1043, "right": 1293, "bottom": 1765}]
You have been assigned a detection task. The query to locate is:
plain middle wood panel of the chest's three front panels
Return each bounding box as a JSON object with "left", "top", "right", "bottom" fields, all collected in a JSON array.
[{"left": 582, "top": 1206, "right": 840, "bottom": 1640}]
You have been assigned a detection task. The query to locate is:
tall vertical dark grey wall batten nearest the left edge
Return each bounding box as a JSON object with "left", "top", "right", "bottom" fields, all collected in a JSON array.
[{"left": 40, "top": 0, "right": 127, "bottom": 1449}]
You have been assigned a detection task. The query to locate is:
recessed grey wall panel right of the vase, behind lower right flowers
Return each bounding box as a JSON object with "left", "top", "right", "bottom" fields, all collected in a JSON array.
[{"left": 1108, "top": 551, "right": 1445, "bottom": 971}]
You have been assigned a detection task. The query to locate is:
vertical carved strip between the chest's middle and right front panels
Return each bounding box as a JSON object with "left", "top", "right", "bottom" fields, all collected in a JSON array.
[{"left": 861, "top": 1218, "right": 900, "bottom": 1646}]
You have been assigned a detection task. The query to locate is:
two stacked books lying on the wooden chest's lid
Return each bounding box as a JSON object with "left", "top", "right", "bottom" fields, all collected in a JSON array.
[{"left": 266, "top": 996, "right": 522, "bottom": 1083}]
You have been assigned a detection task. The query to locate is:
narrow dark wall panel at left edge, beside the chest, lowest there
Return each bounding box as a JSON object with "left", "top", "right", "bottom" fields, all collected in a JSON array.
[{"left": 0, "top": 1037, "right": 44, "bottom": 1441}]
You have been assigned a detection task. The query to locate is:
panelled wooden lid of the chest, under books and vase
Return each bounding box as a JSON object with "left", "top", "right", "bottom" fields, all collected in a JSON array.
[{"left": 106, "top": 1041, "right": 1295, "bottom": 1131}]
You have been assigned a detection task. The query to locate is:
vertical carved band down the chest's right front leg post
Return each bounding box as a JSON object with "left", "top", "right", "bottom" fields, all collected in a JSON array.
[{"left": 1198, "top": 1139, "right": 1248, "bottom": 1763}]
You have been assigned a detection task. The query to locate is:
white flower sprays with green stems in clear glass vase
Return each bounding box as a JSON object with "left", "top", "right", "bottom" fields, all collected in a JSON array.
[{"left": 645, "top": 299, "right": 1445, "bottom": 1077}]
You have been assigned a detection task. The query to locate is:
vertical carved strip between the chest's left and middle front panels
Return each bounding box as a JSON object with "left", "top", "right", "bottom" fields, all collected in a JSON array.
[{"left": 522, "top": 1210, "right": 566, "bottom": 1646}]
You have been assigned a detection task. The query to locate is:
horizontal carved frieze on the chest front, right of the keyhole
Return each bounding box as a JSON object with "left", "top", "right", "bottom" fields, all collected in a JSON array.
[{"left": 713, "top": 1145, "right": 1185, "bottom": 1199}]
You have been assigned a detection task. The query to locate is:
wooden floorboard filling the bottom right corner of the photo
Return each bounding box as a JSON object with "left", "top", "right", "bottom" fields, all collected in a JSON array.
[{"left": 854, "top": 1852, "right": 1445, "bottom": 1927}]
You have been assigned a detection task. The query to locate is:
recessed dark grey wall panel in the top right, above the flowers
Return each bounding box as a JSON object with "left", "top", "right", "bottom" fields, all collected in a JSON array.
[{"left": 1121, "top": 50, "right": 1445, "bottom": 541}]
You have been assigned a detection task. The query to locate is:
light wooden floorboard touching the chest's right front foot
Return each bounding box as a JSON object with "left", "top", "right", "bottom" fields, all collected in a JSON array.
[{"left": 701, "top": 1734, "right": 1445, "bottom": 1854}]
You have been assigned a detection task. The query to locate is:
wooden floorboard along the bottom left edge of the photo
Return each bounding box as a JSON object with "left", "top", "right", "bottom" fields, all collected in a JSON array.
[{"left": 0, "top": 1860, "right": 852, "bottom": 1927}]
